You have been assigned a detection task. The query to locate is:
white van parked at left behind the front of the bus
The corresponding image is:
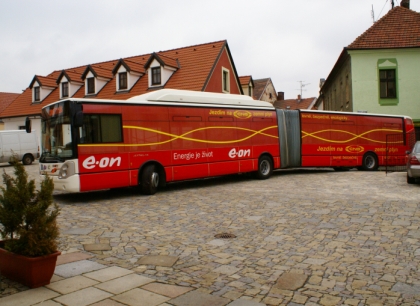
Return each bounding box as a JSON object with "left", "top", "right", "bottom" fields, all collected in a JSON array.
[{"left": 0, "top": 130, "right": 39, "bottom": 165}]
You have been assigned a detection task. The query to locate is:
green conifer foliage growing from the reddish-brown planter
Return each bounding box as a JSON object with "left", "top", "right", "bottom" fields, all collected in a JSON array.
[{"left": 0, "top": 156, "right": 60, "bottom": 257}]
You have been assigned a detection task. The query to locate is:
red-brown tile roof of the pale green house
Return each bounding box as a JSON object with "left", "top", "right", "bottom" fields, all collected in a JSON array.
[{"left": 348, "top": 6, "right": 420, "bottom": 49}]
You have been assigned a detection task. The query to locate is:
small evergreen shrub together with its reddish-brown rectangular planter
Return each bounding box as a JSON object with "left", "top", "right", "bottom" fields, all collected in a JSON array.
[{"left": 0, "top": 156, "right": 61, "bottom": 288}]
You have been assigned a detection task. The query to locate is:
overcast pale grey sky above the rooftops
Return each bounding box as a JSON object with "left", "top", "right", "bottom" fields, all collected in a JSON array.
[{"left": 0, "top": 0, "right": 420, "bottom": 99}]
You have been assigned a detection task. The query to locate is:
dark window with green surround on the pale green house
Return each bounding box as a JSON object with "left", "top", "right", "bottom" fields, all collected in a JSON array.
[{"left": 377, "top": 58, "right": 398, "bottom": 106}]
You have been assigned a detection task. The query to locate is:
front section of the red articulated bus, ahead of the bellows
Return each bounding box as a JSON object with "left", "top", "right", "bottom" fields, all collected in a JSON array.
[{"left": 40, "top": 89, "right": 280, "bottom": 194}]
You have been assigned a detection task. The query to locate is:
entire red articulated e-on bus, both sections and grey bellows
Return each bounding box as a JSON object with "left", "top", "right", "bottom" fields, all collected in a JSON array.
[{"left": 39, "top": 89, "right": 414, "bottom": 194}]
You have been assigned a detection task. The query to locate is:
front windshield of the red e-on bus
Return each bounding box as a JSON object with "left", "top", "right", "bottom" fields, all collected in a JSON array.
[{"left": 40, "top": 102, "right": 75, "bottom": 162}]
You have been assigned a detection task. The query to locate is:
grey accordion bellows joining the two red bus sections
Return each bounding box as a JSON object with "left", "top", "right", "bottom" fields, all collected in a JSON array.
[{"left": 276, "top": 109, "right": 302, "bottom": 168}]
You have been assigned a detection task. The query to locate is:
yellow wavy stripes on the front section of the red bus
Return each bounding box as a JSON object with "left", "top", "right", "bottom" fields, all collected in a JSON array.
[{"left": 79, "top": 125, "right": 278, "bottom": 147}]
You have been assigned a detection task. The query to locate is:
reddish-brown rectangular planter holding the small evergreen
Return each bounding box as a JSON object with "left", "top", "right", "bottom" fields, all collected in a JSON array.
[{"left": 0, "top": 241, "right": 61, "bottom": 288}]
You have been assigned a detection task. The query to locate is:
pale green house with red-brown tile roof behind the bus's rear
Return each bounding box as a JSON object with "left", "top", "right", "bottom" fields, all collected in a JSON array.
[{"left": 319, "top": 1, "right": 420, "bottom": 134}]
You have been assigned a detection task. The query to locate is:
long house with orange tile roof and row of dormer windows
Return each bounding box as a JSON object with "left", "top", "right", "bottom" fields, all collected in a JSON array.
[{"left": 0, "top": 40, "right": 243, "bottom": 135}]
